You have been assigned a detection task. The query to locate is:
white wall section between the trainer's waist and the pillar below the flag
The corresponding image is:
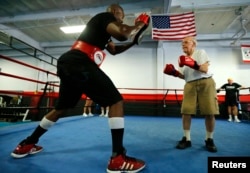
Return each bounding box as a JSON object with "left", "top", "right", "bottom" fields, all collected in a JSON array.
[{"left": 101, "top": 44, "right": 158, "bottom": 93}]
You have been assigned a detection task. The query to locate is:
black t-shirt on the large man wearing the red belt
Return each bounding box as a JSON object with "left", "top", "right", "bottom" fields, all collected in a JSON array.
[{"left": 77, "top": 12, "right": 116, "bottom": 50}]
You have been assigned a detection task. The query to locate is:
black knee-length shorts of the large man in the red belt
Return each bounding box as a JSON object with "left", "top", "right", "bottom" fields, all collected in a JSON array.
[{"left": 55, "top": 50, "right": 123, "bottom": 109}]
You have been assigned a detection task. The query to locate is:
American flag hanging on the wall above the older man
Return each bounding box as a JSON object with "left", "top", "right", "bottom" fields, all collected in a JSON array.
[{"left": 151, "top": 12, "right": 196, "bottom": 40}]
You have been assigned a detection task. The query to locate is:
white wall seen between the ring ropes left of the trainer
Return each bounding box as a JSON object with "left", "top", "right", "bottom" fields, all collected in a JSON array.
[{"left": 0, "top": 57, "right": 59, "bottom": 92}]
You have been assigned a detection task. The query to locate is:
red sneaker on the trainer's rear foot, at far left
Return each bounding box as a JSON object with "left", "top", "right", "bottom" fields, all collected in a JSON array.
[{"left": 11, "top": 144, "right": 43, "bottom": 158}]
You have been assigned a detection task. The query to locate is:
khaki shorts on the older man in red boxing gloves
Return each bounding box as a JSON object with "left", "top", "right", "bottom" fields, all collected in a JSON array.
[{"left": 181, "top": 78, "right": 219, "bottom": 115}]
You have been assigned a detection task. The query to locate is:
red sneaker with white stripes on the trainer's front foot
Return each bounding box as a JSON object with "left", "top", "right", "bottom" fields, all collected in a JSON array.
[{"left": 107, "top": 154, "right": 145, "bottom": 173}]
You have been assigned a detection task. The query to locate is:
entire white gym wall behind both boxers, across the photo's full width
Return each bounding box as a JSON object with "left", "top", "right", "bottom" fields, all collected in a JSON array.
[{"left": 0, "top": 41, "right": 250, "bottom": 93}]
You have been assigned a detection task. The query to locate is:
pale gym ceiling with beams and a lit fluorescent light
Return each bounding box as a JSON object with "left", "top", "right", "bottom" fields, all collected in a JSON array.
[{"left": 0, "top": 0, "right": 250, "bottom": 57}]
